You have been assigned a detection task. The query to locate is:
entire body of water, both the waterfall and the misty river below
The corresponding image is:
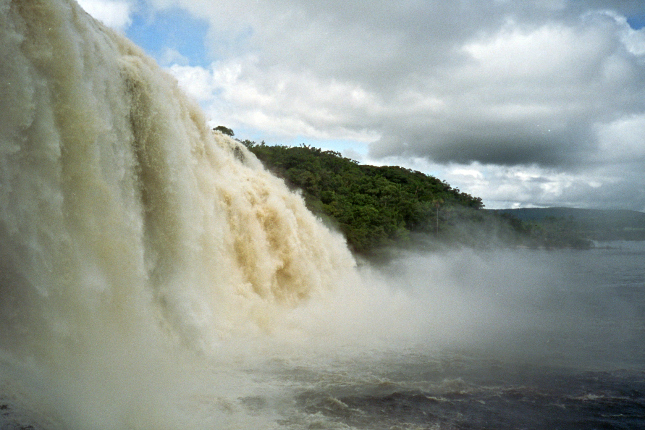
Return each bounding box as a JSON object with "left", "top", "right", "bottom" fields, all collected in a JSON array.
[{"left": 5, "top": 0, "right": 645, "bottom": 430}]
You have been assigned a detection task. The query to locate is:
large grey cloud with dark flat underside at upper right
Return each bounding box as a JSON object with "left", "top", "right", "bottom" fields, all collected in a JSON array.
[{"left": 371, "top": 7, "right": 645, "bottom": 167}]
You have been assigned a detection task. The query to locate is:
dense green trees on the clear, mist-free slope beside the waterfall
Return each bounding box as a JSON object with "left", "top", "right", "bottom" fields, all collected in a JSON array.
[{"left": 242, "top": 141, "right": 483, "bottom": 253}]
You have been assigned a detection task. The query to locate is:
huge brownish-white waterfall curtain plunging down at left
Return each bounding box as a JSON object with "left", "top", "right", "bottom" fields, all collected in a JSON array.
[{"left": 0, "top": 0, "right": 355, "bottom": 428}]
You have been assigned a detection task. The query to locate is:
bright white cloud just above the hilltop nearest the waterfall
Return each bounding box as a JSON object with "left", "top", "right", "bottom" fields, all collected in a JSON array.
[{"left": 169, "top": 57, "right": 379, "bottom": 142}]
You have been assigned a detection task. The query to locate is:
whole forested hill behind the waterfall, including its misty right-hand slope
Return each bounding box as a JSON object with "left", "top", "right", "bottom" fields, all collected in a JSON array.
[{"left": 225, "top": 128, "right": 591, "bottom": 257}]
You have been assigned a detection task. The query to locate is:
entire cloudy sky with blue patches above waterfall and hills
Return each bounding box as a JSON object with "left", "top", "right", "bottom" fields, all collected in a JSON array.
[{"left": 79, "top": 0, "right": 645, "bottom": 211}]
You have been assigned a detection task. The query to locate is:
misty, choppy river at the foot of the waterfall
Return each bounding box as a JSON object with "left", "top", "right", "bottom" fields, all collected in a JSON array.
[{"left": 2, "top": 242, "right": 645, "bottom": 430}]
